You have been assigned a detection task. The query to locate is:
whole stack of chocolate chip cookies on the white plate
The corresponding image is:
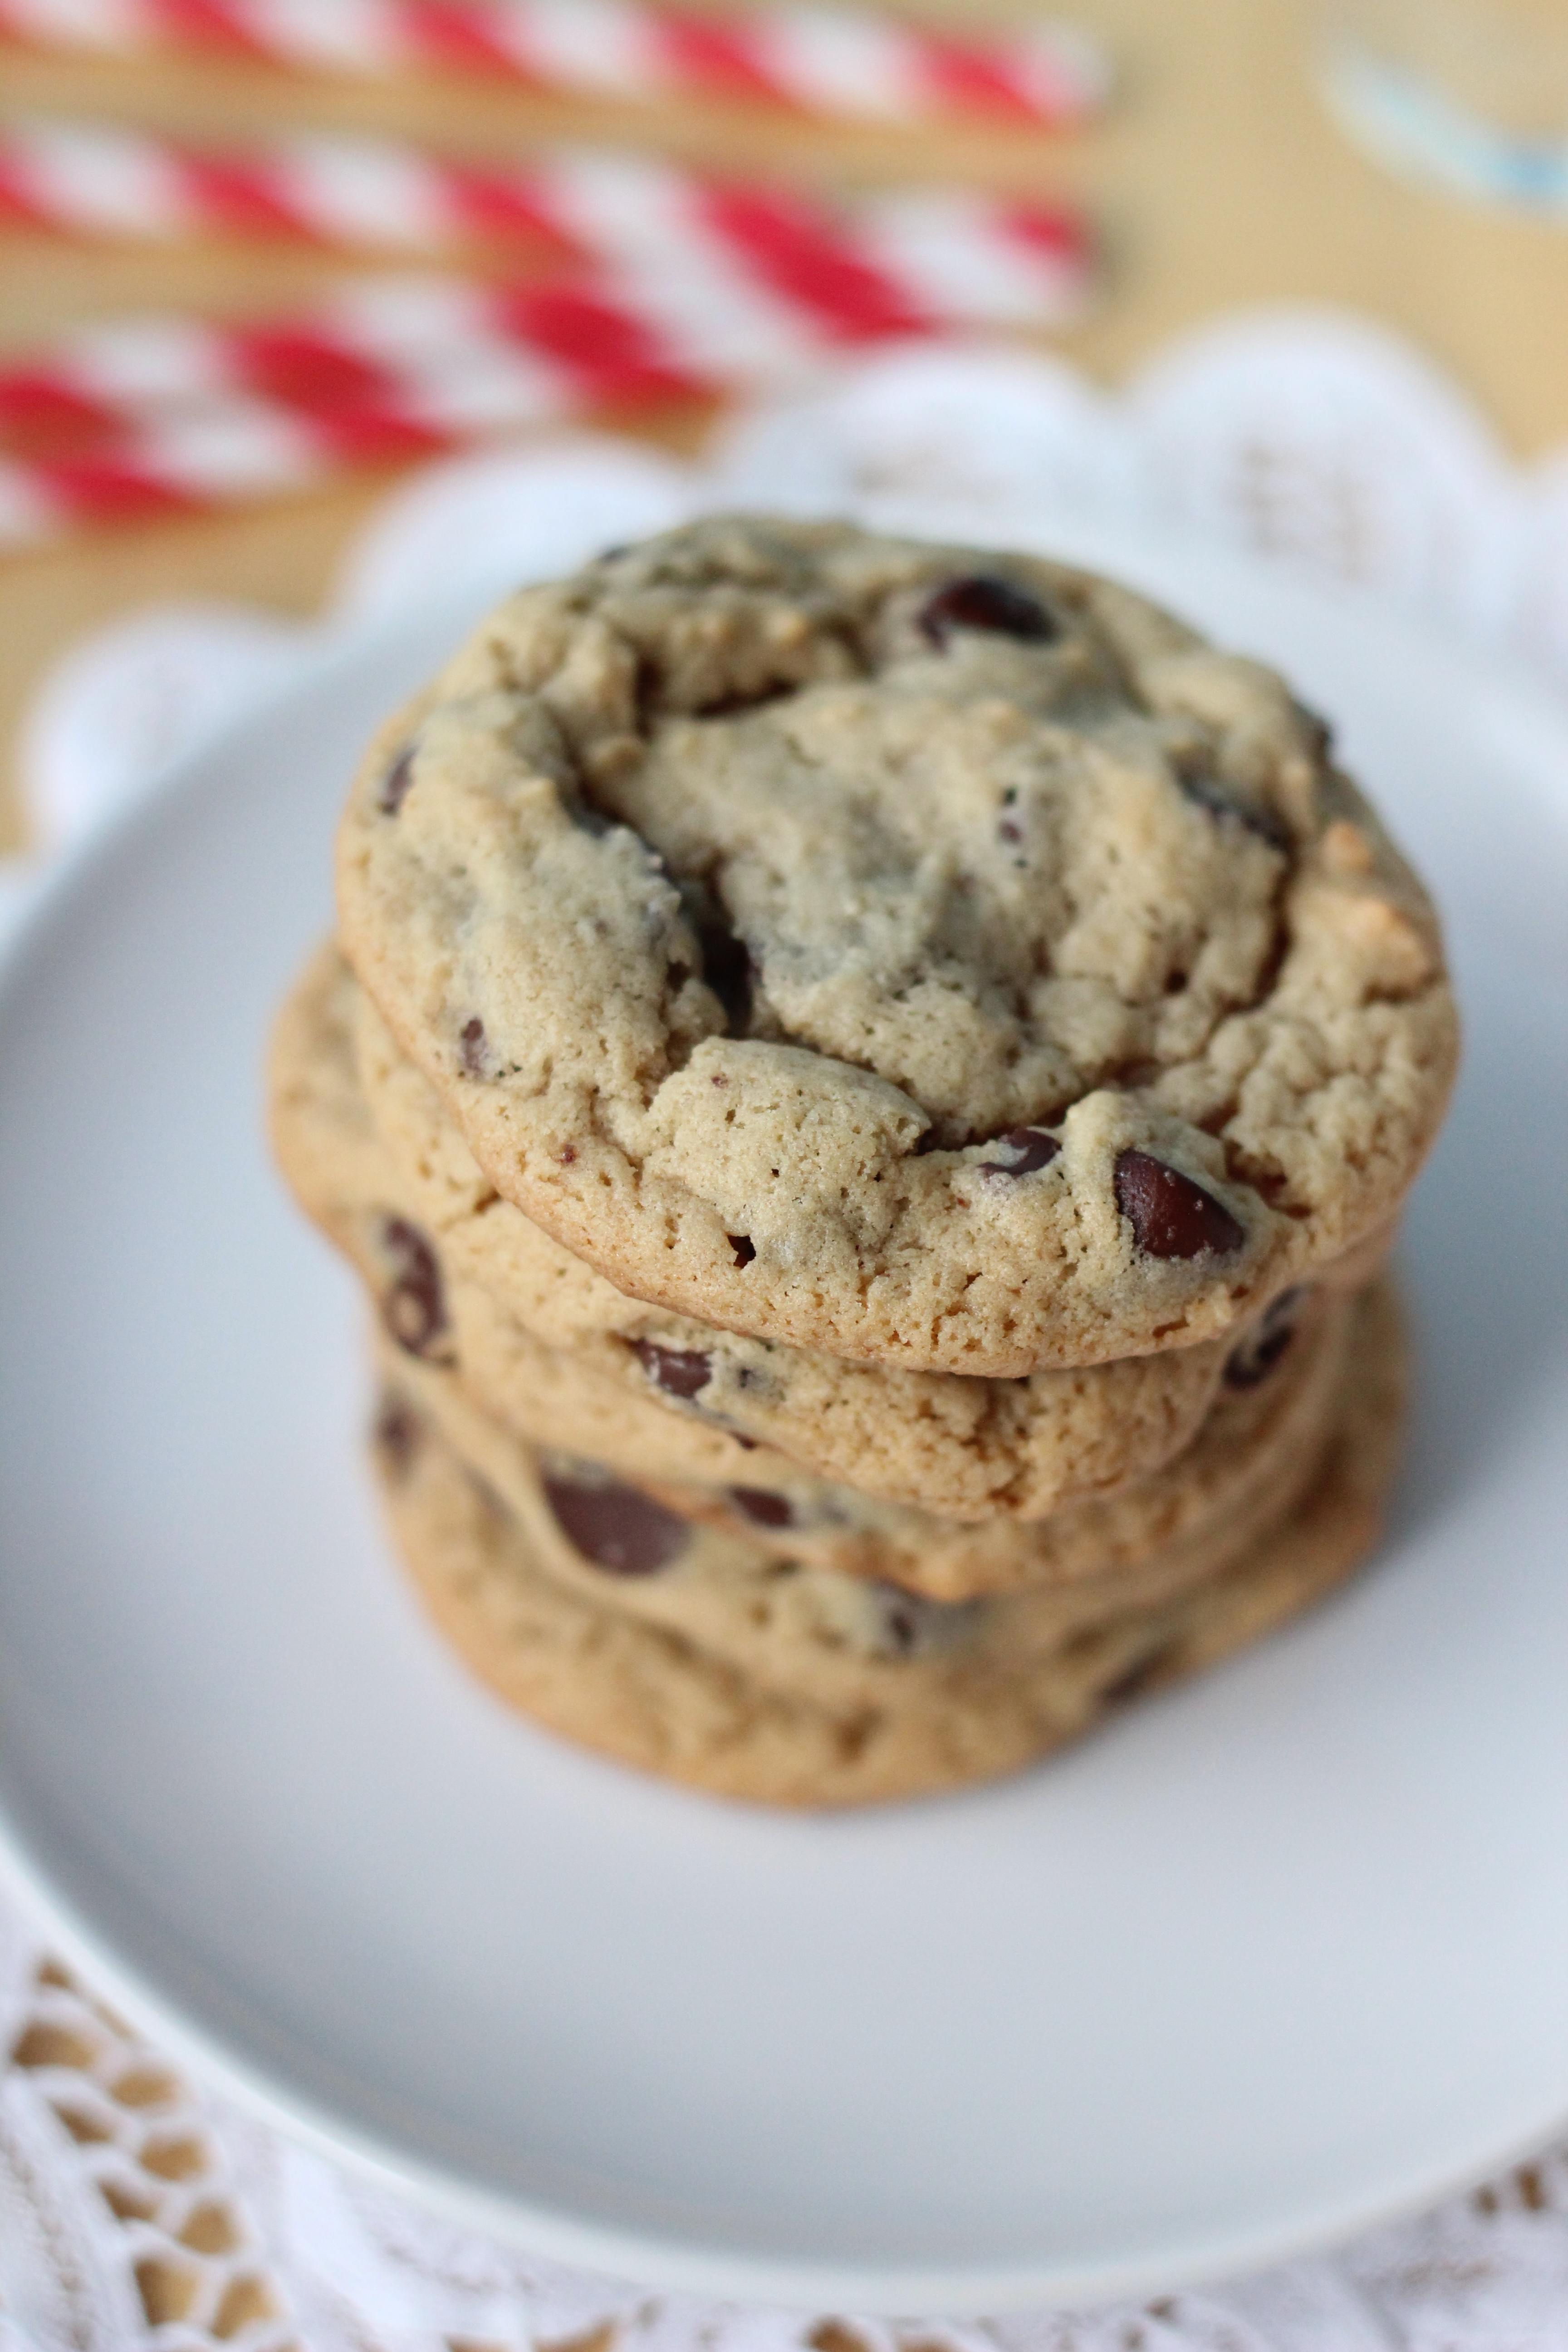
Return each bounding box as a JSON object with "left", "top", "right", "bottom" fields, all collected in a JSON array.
[{"left": 273, "top": 517, "right": 1455, "bottom": 1804}]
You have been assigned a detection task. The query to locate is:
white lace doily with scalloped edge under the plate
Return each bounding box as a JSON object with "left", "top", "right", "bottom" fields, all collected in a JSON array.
[{"left": 0, "top": 313, "right": 1568, "bottom": 2352}]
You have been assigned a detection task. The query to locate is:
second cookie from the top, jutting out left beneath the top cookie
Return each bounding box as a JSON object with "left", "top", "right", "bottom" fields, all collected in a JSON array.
[{"left": 270, "top": 948, "right": 1260, "bottom": 1519}]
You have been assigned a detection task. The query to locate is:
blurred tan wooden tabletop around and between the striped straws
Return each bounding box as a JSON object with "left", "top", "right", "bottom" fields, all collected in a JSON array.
[{"left": 0, "top": 0, "right": 1568, "bottom": 844}]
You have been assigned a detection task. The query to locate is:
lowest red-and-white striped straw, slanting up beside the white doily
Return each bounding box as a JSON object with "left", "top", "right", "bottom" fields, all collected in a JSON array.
[{"left": 0, "top": 255, "right": 1109, "bottom": 548}]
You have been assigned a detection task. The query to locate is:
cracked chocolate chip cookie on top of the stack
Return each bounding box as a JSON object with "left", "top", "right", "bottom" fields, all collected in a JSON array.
[{"left": 338, "top": 517, "right": 1455, "bottom": 1378}]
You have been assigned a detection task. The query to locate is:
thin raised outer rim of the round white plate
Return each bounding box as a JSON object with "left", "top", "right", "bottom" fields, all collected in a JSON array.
[{"left": 0, "top": 515, "right": 1568, "bottom": 2319}]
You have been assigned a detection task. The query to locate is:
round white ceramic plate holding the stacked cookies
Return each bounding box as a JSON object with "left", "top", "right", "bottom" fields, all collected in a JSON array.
[{"left": 0, "top": 519, "right": 1568, "bottom": 2312}]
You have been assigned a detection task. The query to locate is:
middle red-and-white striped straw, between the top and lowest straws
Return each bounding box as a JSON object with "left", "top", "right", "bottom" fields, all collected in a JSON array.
[{"left": 0, "top": 122, "right": 1093, "bottom": 338}]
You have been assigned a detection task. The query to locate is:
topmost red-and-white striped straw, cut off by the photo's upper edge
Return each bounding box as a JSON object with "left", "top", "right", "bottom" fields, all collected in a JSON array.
[{"left": 0, "top": 0, "right": 1110, "bottom": 125}]
